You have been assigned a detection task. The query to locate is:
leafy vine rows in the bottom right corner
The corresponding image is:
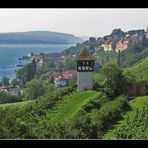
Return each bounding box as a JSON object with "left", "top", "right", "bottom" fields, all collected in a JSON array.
[{"left": 114, "top": 105, "right": 148, "bottom": 139}]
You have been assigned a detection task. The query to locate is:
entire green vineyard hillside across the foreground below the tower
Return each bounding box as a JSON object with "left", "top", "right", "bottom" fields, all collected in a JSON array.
[{"left": 0, "top": 83, "right": 148, "bottom": 139}]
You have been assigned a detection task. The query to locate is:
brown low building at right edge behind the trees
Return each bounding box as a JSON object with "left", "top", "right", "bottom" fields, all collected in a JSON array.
[{"left": 128, "top": 83, "right": 148, "bottom": 96}]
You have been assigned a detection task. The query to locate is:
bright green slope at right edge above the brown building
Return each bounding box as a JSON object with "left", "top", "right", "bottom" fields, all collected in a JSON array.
[{"left": 125, "top": 57, "right": 148, "bottom": 81}]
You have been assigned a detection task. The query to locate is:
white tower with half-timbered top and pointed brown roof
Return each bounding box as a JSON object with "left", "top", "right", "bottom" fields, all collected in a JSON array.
[{"left": 76, "top": 48, "right": 95, "bottom": 91}]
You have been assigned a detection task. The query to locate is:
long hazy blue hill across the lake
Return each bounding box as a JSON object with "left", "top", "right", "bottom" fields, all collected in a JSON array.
[{"left": 0, "top": 31, "right": 82, "bottom": 44}]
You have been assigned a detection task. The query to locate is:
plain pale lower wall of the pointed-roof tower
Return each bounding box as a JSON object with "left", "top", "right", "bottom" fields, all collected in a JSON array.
[{"left": 77, "top": 72, "right": 92, "bottom": 91}]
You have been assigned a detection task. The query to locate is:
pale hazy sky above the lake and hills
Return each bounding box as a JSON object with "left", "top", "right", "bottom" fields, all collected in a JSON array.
[{"left": 0, "top": 8, "right": 148, "bottom": 36}]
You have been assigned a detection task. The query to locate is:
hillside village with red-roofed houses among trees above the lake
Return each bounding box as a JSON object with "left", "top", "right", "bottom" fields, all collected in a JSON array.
[{"left": 0, "top": 27, "right": 148, "bottom": 95}]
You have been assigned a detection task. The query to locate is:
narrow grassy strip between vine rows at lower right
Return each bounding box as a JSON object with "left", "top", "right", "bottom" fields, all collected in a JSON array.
[{"left": 104, "top": 96, "right": 148, "bottom": 139}]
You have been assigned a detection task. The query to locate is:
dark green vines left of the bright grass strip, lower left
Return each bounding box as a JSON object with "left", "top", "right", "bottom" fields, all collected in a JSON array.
[{"left": 0, "top": 87, "right": 74, "bottom": 139}]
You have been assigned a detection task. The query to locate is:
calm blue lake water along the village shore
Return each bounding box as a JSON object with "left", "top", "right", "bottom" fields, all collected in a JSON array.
[{"left": 0, "top": 44, "right": 73, "bottom": 79}]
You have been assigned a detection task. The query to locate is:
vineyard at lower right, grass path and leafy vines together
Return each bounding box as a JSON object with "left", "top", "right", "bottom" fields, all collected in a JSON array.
[{"left": 104, "top": 96, "right": 148, "bottom": 139}]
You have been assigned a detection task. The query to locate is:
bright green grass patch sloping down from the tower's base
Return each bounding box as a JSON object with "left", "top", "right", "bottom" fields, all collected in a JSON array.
[{"left": 42, "top": 90, "right": 98, "bottom": 123}]
